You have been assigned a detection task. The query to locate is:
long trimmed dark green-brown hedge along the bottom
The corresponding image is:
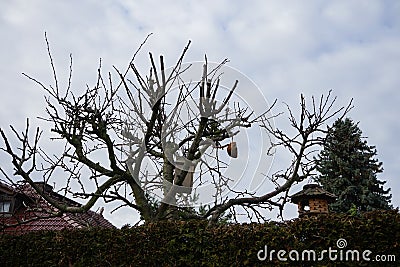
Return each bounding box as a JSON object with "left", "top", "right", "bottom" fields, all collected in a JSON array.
[{"left": 0, "top": 211, "right": 400, "bottom": 266}]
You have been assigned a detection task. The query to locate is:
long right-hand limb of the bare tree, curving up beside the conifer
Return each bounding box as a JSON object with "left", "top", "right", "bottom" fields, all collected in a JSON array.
[{"left": 208, "top": 91, "right": 352, "bottom": 221}]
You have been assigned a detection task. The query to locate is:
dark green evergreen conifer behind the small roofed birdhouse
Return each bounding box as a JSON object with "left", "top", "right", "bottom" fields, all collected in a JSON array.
[{"left": 316, "top": 118, "right": 392, "bottom": 212}]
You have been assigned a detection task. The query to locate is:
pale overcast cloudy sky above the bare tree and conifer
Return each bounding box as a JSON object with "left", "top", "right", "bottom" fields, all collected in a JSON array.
[{"left": 0, "top": 0, "right": 400, "bottom": 228}]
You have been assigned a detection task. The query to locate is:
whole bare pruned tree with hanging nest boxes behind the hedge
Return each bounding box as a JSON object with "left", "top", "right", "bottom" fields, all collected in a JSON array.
[{"left": 0, "top": 33, "right": 351, "bottom": 224}]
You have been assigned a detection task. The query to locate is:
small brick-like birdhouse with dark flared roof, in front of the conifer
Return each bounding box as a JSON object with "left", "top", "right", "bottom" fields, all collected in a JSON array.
[{"left": 290, "top": 184, "right": 336, "bottom": 217}]
